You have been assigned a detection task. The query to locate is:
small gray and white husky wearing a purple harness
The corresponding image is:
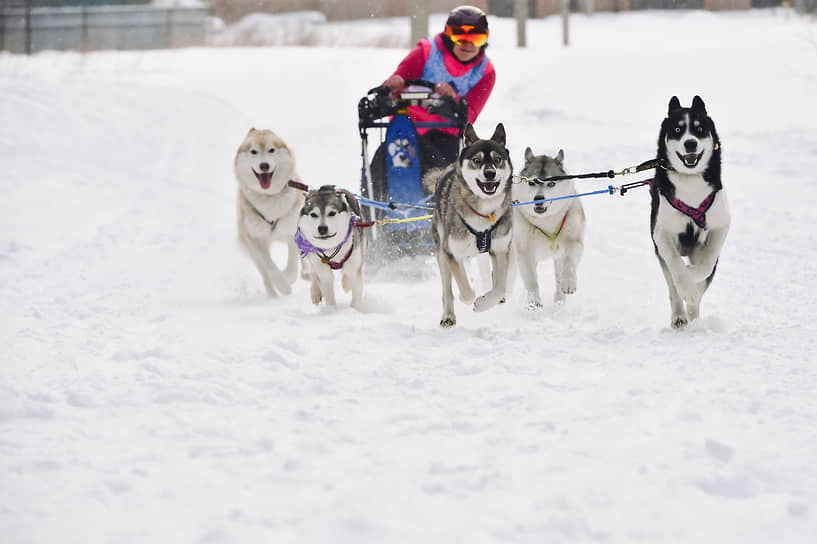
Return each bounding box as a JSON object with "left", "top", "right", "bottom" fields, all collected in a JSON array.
[{"left": 295, "top": 185, "right": 367, "bottom": 311}]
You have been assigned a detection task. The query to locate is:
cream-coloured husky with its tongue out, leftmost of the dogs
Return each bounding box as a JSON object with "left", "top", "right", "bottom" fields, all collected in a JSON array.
[{"left": 233, "top": 128, "right": 304, "bottom": 296}]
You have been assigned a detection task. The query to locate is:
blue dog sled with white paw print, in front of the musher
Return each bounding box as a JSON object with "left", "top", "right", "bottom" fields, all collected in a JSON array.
[{"left": 358, "top": 80, "right": 468, "bottom": 260}]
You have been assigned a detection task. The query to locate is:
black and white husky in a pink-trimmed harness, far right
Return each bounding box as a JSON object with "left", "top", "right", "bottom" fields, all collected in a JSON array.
[{"left": 650, "top": 96, "right": 729, "bottom": 328}]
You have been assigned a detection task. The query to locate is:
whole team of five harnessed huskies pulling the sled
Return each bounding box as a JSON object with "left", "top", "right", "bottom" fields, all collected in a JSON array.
[{"left": 234, "top": 96, "right": 730, "bottom": 328}]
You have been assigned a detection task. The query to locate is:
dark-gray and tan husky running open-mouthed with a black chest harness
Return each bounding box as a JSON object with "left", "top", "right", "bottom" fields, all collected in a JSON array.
[{"left": 424, "top": 123, "right": 513, "bottom": 327}]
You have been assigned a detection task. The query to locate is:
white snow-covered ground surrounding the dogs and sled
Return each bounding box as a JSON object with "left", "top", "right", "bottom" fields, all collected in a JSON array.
[{"left": 0, "top": 10, "right": 817, "bottom": 544}]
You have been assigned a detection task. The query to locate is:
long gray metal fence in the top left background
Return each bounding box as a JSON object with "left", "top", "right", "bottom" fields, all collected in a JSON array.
[{"left": 0, "top": 0, "right": 208, "bottom": 54}]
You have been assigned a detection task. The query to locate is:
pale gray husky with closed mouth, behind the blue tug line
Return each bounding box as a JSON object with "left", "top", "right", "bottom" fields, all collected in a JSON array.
[{"left": 511, "top": 148, "right": 585, "bottom": 310}]
